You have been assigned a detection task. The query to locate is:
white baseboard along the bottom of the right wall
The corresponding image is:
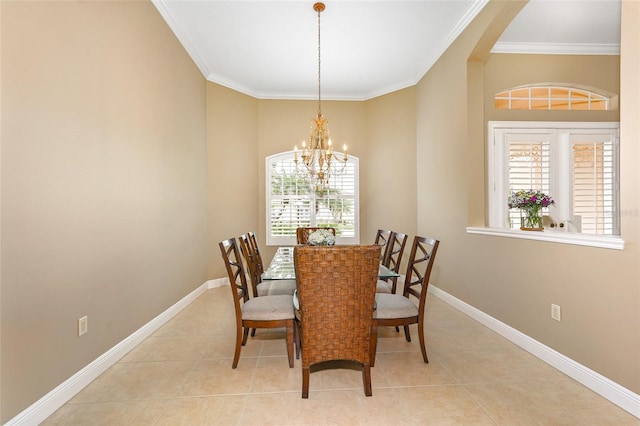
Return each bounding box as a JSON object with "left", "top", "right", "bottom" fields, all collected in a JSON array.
[{"left": 429, "top": 284, "right": 640, "bottom": 418}]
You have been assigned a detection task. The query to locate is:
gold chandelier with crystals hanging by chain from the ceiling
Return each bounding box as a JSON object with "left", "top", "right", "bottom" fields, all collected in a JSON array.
[{"left": 294, "top": 2, "right": 348, "bottom": 192}]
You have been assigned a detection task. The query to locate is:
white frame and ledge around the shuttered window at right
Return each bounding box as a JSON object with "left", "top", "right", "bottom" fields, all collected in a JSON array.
[{"left": 480, "top": 121, "right": 624, "bottom": 250}]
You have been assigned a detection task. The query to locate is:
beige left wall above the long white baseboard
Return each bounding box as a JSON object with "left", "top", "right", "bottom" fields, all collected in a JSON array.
[{"left": 0, "top": 1, "right": 207, "bottom": 423}]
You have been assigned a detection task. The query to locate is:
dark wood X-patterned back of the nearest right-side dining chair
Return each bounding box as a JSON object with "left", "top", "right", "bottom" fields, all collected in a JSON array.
[{"left": 403, "top": 236, "right": 440, "bottom": 312}]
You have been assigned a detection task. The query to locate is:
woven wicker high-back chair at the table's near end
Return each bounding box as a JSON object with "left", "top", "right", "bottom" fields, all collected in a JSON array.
[{"left": 294, "top": 245, "right": 380, "bottom": 398}]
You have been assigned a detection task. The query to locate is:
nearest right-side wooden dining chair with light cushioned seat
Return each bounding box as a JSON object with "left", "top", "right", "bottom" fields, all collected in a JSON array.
[{"left": 371, "top": 236, "right": 440, "bottom": 367}]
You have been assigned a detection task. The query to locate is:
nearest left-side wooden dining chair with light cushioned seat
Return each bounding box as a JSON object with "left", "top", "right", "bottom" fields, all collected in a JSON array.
[{"left": 219, "top": 238, "right": 295, "bottom": 368}]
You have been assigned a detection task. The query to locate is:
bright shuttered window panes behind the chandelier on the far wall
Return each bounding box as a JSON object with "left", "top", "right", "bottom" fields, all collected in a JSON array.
[{"left": 266, "top": 151, "right": 359, "bottom": 245}]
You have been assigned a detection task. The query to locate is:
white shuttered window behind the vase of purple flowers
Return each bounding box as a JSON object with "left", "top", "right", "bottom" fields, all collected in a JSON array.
[{"left": 488, "top": 122, "right": 620, "bottom": 236}]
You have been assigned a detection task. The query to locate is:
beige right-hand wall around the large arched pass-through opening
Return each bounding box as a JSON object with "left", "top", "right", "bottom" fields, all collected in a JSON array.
[{"left": 417, "top": 1, "right": 640, "bottom": 393}]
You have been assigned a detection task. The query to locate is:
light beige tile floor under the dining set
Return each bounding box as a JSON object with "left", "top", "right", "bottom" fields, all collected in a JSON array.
[{"left": 44, "top": 287, "right": 640, "bottom": 426}]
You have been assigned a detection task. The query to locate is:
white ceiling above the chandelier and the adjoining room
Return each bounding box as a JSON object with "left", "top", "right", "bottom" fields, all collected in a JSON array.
[{"left": 152, "top": 0, "right": 620, "bottom": 100}]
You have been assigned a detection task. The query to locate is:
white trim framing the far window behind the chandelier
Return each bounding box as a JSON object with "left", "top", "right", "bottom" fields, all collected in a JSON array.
[{"left": 265, "top": 151, "right": 360, "bottom": 246}]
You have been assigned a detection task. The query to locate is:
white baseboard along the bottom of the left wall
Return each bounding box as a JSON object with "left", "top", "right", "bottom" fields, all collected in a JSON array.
[{"left": 5, "top": 278, "right": 210, "bottom": 426}]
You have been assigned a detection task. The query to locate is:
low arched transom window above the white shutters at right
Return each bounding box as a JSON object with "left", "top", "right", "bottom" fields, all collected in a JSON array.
[{"left": 494, "top": 85, "right": 613, "bottom": 111}]
